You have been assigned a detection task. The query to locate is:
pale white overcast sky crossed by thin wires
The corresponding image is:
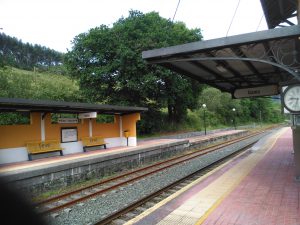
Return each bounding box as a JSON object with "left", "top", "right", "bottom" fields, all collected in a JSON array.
[{"left": 0, "top": 0, "right": 267, "bottom": 52}]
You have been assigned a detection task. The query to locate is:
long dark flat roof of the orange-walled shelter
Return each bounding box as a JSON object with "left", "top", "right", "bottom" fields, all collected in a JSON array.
[{"left": 0, "top": 98, "right": 148, "bottom": 115}]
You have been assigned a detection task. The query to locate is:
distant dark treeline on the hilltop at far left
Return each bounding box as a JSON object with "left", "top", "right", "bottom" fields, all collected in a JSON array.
[{"left": 0, "top": 33, "right": 63, "bottom": 72}]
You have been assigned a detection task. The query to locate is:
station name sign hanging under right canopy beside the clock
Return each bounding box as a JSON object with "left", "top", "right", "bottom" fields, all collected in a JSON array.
[{"left": 233, "top": 85, "right": 279, "bottom": 98}]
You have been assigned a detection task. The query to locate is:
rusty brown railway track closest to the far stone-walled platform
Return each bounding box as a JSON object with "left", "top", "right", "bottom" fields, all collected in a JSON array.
[{"left": 36, "top": 127, "right": 274, "bottom": 217}]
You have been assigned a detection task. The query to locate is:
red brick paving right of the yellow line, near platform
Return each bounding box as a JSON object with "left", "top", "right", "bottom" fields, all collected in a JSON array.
[{"left": 202, "top": 130, "right": 300, "bottom": 225}]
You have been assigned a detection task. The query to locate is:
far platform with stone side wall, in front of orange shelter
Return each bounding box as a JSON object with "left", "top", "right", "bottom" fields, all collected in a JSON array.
[{"left": 0, "top": 130, "right": 246, "bottom": 195}]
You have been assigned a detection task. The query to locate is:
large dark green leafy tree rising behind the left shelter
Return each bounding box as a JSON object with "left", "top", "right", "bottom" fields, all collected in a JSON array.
[{"left": 65, "top": 11, "right": 202, "bottom": 133}]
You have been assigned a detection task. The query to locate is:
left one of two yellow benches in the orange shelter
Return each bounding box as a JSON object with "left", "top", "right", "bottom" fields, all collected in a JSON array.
[{"left": 26, "top": 140, "right": 63, "bottom": 161}]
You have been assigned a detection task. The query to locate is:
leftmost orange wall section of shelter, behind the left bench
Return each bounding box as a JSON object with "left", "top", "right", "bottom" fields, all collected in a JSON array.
[{"left": 0, "top": 113, "right": 41, "bottom": 148}]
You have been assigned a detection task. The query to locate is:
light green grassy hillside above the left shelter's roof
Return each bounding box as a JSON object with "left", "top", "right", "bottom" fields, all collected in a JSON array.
[{"left": 0, "top": 67, "right": 82, "bottom": 101}]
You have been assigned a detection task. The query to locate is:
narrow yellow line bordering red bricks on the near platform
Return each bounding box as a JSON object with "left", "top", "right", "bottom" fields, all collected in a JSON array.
[{"left": 195, "top": 129, "right": 285, "bottom": 225}]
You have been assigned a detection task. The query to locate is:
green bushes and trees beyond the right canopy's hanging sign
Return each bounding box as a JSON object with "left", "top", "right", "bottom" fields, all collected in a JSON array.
[{"left": 199, "top": 87, "right": 284, "bottom": 126}]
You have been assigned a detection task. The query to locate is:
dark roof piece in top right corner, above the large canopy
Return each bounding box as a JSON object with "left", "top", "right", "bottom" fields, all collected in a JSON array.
[{"left": 260, "top": 0, "right": 297, "bottom": 29}]
